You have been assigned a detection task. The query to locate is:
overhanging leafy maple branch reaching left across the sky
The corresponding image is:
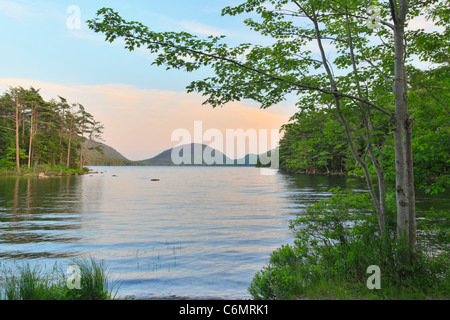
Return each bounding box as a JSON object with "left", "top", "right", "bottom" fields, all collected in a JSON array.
[{"left": 88, "top": 1, "right": 390, "bottom": 108}]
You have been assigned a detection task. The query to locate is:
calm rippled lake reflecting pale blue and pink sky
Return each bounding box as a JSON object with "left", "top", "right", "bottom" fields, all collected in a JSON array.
[{"left": 0, "top": 167, "right": 448, "bottom": 299}]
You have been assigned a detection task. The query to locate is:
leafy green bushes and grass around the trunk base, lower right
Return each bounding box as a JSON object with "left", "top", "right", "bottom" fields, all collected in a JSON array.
[{"left": 248, "top": 189, "right": 450, "bottom": 299}]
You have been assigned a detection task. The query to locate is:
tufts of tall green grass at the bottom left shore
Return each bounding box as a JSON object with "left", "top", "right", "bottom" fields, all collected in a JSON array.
[{"left": 0, "top": 258, "right": 117, "bottom": 300}]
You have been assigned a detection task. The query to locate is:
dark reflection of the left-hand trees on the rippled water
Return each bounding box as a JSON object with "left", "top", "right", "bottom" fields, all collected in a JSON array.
[{"left": 0, "top": 176, "right": 82, "bottom": 259}]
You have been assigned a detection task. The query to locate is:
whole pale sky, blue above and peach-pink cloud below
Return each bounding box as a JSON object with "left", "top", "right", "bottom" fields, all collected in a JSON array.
[{"left": 0, "top": 0, "right": 295, "bottom": 160}]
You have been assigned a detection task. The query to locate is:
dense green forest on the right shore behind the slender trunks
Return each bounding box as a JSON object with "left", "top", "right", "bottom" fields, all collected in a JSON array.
[{"left": 280, "top": 59, "right": 450, "bottom": 192}]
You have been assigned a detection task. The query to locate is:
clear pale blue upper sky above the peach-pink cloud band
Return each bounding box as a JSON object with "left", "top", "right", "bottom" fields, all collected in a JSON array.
[{"left": 0, "top": 0, "right": 256, "bottom": 90}]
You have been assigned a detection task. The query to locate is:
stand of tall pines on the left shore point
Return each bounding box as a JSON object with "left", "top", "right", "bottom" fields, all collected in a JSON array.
[{"left": 0, "top": 86, "right": 103, "bottom": 174}]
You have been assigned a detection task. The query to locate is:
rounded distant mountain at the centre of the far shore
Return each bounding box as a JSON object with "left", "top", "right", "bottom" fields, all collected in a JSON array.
[{"left": 137, "top": 143, "right": 257, "bottom": 166}]
